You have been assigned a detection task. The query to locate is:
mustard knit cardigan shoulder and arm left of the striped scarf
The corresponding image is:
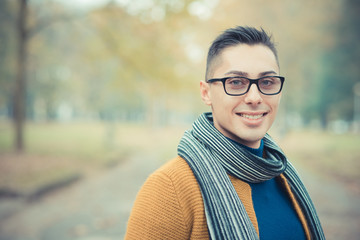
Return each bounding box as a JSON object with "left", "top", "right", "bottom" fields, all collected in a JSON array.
[{"left": 126, "top": 157, "right": 206, "bottom": 239}]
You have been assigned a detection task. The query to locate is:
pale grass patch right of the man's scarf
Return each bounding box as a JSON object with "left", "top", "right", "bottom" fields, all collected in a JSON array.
[{"left": 281, "top": 130, "right": 360, "bottom": 191}]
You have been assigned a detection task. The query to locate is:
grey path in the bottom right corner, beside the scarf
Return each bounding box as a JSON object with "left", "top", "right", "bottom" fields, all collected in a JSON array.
[{"left": 298, "top": 165, "right": 360, "bottom": 240}]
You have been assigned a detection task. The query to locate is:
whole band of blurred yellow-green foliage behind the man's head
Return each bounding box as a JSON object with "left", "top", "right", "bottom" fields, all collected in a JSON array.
[{"left": 0, "top": 0, "right": 360, "bottom": 128}]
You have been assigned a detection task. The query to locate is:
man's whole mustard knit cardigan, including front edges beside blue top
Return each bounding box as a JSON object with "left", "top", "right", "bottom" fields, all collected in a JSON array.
[{"left": 125, "top": 157, "right": 310, "bottom": 240}]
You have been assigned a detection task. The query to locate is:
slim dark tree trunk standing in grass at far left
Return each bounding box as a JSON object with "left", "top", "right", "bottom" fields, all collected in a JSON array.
[{"left": 14, "top": 0, "right": 28, "bottom": 153}]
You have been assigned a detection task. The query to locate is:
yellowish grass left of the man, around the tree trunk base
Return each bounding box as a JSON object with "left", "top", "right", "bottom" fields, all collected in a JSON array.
[{"left": 0, "top": 122, "right": 184, "bottom": 192}]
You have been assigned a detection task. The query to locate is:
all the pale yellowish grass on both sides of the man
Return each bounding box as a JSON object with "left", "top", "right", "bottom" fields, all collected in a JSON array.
[{"left": 0, "top": 122, "right": 360, "bottom": 196}]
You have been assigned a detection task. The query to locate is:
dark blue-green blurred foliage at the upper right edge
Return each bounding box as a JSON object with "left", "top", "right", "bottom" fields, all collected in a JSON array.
[{"left": 308, "top": 0, "right": 360, "bottom": 126}]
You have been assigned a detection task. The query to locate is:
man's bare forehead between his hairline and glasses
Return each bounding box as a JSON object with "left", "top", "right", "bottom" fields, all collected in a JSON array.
[{"left": 213, "top": 44, "right": 279, "bottom": 78}]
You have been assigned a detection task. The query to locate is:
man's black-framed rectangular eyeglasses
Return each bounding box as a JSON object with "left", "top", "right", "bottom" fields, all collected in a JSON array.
[{"left": 206, "top": 76, "right": 285, "bottom": 96}]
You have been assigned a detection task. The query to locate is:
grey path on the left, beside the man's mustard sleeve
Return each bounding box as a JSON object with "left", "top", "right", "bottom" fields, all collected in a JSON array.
[{"left": 0, "top": 152, "right": 160, "bottom": 240}]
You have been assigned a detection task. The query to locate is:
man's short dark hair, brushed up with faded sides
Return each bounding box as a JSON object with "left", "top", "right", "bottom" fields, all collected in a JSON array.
[{"left": 205, "top": 26, "right": 279, "bottom": 79}]
